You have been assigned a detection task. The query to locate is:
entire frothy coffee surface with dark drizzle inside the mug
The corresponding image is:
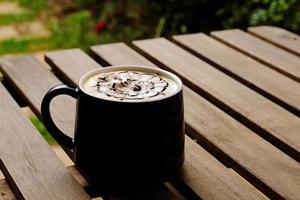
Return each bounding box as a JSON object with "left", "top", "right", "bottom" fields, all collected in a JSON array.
[{"left": 83, "top": 70, "right": 178, "bottom": 101}]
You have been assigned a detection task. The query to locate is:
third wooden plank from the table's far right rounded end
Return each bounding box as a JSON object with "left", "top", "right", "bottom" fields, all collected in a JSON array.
[{"left": 174, "top": 33, "right": 300, "bottom": 116}]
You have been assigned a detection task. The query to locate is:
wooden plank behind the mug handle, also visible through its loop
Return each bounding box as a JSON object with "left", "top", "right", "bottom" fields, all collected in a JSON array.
[{"left": 0, "top": 56, "right": 75, "bottom": 137}]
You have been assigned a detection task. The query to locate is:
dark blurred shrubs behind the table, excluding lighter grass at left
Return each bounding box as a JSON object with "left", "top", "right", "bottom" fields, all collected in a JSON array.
[{"left": 69, "top": 0, "right": 300, "bottom": 42}]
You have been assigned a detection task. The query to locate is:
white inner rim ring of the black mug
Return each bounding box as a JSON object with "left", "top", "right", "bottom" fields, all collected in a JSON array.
[{"left": 78, "top": 64, "right": 183, "bottom": 103}]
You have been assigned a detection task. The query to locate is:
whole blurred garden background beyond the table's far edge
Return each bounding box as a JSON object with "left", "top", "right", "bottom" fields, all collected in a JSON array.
[{"left": 0, "top": 0, "right": 300, "bottom": 55}]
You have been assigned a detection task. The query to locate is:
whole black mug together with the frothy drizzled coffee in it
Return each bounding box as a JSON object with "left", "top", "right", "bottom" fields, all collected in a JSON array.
[{"left": 41, "top": 65, "right": 185, "bottom": 189}]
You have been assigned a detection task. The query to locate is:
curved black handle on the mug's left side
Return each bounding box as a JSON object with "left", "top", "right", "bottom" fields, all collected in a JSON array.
[{"left": 41, "top": 84, "right": 78, "bottom": 149}]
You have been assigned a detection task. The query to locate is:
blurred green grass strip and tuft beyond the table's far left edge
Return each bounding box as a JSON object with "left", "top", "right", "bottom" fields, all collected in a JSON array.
[{"left": 0, "top": 11, "right": 99, "bottom": 55}]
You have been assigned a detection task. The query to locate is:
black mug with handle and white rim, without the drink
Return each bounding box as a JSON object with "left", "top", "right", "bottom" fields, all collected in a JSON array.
[{"left": 41, "top": 65, "right": 184, "bottom": 191}]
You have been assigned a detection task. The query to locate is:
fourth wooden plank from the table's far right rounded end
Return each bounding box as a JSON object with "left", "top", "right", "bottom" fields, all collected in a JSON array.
[{"left": 134, "top": 38, "right": 300, "bottom": 161}]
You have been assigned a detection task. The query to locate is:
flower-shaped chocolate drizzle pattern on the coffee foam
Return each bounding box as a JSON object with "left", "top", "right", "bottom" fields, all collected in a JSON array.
[{"left": 93, "top": 71, "right": 169, "bottom": 100}]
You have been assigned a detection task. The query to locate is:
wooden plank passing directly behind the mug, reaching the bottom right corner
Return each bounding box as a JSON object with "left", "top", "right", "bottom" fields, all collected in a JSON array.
[{"left": 92, "top": 43, "right": 300, "bottom": 199}]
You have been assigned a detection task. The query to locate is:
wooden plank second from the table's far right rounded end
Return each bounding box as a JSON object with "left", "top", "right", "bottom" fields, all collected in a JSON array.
[{"left": 211, "top": 29, "right": 300, "bottom": 82}]
